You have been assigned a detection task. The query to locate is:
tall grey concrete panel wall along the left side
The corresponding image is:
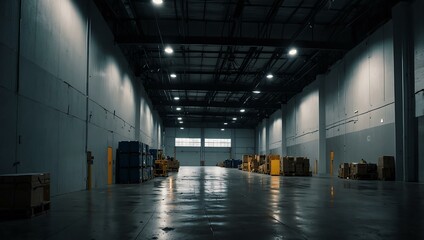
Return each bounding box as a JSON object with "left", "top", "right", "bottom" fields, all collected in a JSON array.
[{"left": 0, "top": 0, "right": 162, "bottom": 195}]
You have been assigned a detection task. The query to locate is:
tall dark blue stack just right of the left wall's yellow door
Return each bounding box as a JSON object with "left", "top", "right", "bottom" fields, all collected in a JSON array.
[{"left": 116, "top": 141, "right": 143, "bottom": 183}]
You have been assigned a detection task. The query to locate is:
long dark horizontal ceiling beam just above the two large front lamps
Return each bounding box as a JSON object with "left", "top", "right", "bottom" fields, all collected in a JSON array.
[{"left": 115, "top": 35, "right": 349, "bottom": 51}]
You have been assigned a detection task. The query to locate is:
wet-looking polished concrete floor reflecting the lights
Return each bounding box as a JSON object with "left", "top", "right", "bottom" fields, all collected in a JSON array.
[{"left": 0, "top": 167, "right": 424, "bottom": 240}]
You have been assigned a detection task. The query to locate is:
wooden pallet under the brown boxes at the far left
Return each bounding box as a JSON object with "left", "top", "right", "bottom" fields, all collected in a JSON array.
[{"left": 0, "top": 201, "right": 50, "bottom": 219}]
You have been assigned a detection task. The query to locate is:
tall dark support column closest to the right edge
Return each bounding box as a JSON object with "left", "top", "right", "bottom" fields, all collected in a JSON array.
[{"left": 392, "top": 2, "right": 418, "bottom": 182}]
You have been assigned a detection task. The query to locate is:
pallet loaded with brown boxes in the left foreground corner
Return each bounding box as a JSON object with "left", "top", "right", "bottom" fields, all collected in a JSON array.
[{"left": 0, "top": 173, "right": 50, "bottom": 218}]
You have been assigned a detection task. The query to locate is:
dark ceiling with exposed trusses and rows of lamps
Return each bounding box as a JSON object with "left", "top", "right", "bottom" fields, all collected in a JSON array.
[{"left": 95, "top": 0, "right": 399, "bottom": 128}]
